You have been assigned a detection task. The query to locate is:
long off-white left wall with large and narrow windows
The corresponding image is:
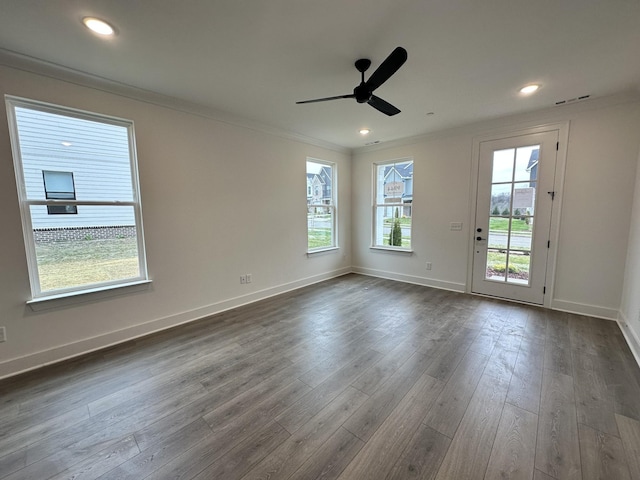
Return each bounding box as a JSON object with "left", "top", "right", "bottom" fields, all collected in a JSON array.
[{"left": 0, "top": 66, "right": 351, "bottom": 377}]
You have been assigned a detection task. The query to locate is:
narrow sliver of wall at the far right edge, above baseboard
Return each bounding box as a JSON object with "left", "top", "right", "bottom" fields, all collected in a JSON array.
[{"left": 619, "top": 144, "right": 640, "bottom": 363}]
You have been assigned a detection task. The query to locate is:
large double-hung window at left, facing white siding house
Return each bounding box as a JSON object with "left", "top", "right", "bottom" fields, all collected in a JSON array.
[{"left": 7, "top": 97, "right": 147, "bottom": 300}]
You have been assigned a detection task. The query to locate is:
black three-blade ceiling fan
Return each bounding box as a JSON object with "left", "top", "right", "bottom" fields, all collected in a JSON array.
[{"left": 296, "top": 47, "right": 407, "bottom": 116}]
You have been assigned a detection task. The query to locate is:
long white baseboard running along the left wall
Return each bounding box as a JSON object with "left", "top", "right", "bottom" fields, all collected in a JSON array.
[{"left": 0, "top": 267, "right": 352, "bottom": 379}]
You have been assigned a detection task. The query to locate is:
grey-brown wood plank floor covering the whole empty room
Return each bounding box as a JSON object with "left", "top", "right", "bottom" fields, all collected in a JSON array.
[{"left": 0, "top": 275, "right": 640, "bottom": 480}]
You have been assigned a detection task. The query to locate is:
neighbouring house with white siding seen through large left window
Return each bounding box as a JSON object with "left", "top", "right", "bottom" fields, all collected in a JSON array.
[{"left": 16, "top": 108, "right": 135, "bottom": 230}]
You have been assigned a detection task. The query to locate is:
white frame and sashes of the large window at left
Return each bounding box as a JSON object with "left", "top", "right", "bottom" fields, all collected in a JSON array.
[{"left": 5, "top": 95, "right": 149, "bottom": 303}]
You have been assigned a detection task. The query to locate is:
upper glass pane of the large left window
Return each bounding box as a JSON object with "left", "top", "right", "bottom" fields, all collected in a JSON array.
[{"left": 15, "top": 107, "right": 133, "bottom": 201}]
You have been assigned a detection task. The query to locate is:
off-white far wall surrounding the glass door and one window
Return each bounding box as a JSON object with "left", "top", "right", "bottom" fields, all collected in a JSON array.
[{"left": 353, "top": 95, "right": 640, "bottom": 319}]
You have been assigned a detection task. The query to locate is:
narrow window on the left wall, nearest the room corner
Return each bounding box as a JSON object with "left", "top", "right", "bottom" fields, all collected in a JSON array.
[{"left": 307, "top": 159, "right": 337, "bottom": 252}]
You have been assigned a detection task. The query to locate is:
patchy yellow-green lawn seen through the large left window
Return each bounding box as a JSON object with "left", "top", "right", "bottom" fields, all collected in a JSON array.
[{"left": 36, "top": 238, "right": 140, "bottom": 292}]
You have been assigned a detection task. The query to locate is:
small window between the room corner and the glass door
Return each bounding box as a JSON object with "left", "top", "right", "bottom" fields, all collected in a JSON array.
[{"left": 373, "top": 158, "right": 413, "bottom": 250}]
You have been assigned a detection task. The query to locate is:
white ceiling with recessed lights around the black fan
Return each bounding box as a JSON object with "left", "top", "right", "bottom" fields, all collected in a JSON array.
[{"left": 0, "top": 0, "right": 640, "bottom": 148}]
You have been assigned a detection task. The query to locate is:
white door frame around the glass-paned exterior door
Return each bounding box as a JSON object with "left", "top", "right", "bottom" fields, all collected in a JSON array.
[{"left": 465, "top": 121, "right": 569, "bottom": 308}]
